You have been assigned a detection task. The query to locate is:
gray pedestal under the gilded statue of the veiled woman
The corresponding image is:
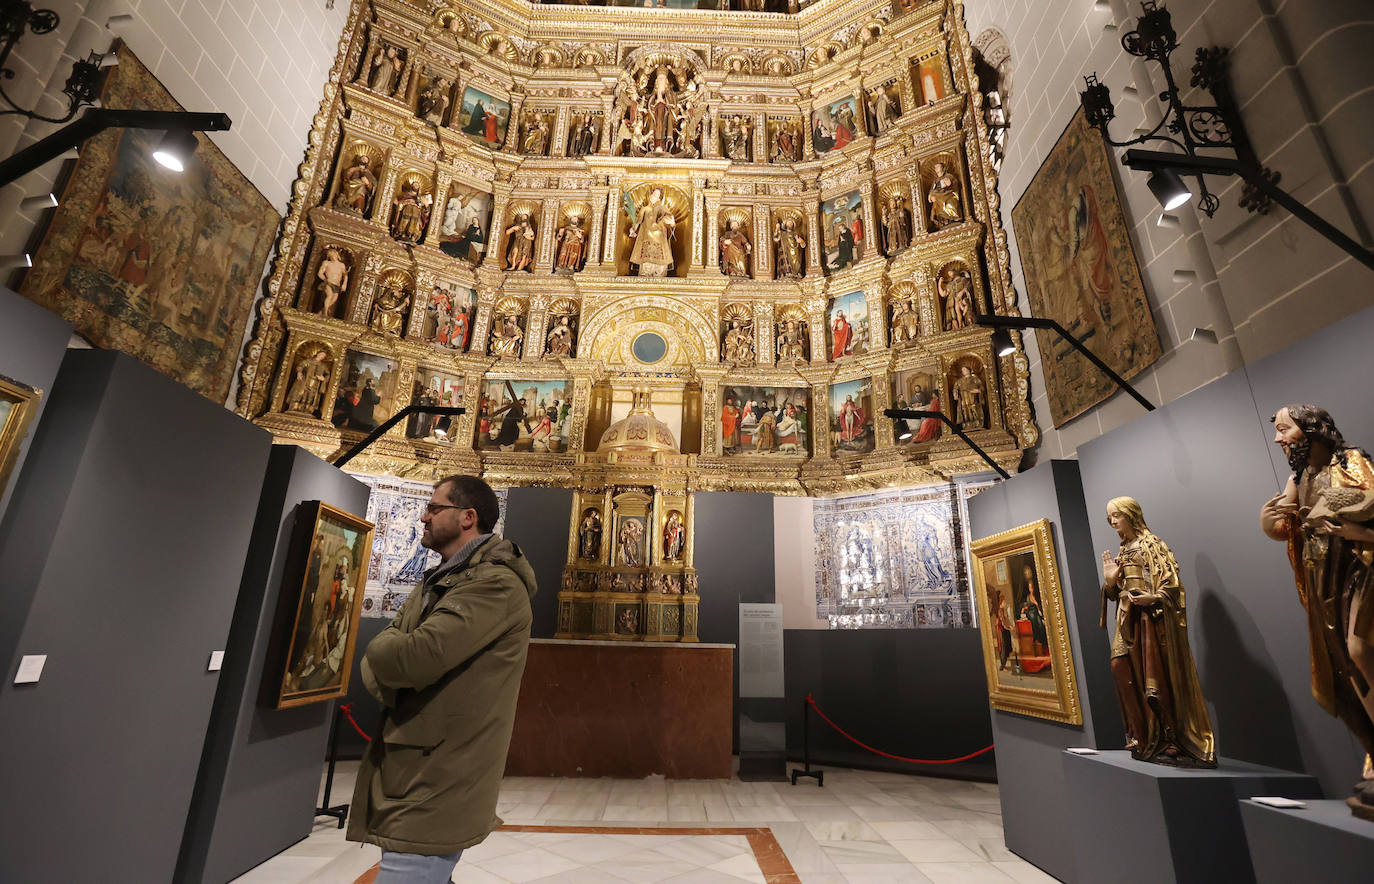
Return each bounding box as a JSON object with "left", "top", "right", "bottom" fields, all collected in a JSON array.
[{"left": 1063, "top": 749, "right": 1322, "bottom": 884}]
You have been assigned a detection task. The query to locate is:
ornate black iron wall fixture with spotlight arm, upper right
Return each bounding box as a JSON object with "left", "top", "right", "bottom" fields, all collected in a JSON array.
[{"left": 1079, "top": 0, "right": 1374, "bottom": 269}]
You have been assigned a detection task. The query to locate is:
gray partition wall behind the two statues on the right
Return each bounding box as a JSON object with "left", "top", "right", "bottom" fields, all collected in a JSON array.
[{"left": 1079, "top": 302, "right": 1374, "bottom": 797}]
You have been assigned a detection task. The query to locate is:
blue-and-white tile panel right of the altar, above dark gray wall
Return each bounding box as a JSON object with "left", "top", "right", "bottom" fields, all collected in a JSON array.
[{"left": 813, "top": 485, "right": 973, "bottom": 628}]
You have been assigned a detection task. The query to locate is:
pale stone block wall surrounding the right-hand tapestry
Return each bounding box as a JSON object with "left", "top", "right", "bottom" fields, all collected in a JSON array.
[{"left": 965, "top": 0, "right": 1374, "bottom": 459}]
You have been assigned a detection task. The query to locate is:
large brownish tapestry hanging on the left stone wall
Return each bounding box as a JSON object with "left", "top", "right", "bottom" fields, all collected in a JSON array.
[{"left": 19, "top": 45, "right": 282, "bottom": 401}]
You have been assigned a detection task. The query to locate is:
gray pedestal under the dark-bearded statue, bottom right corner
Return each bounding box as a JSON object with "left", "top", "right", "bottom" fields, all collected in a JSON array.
[{"left": 1241, "top": 802, "right": 1374, "bottom": 884}]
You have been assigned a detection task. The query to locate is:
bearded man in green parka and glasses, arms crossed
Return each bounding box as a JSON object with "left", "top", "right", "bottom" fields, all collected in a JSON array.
[{"left": 348, "top": 476, "right": 536, "bottom": 884}]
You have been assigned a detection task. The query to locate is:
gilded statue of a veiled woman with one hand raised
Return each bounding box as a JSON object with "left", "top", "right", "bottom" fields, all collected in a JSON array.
[{"left": 1099, "top": 498, "right": 1216, "bottom": 767}]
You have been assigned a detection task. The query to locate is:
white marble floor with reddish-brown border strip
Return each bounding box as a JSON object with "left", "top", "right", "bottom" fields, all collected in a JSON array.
[{"left": 235, "top": 766, "right": 1054, "bottom": 884}]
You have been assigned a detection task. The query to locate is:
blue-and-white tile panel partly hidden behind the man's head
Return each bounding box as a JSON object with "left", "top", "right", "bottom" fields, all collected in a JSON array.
[{"left": 350, "top": 473, "right": 507, "bottom": 619}]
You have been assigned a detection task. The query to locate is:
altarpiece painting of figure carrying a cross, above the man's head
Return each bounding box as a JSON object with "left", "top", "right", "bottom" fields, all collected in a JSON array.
[{"left": 477, "top": 378, "right": 573, "bottom": 454}]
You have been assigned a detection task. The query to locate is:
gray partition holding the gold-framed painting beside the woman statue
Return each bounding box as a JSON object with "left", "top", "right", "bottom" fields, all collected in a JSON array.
[{"left": 969, "top": 461, "right": 1124, "bottom": 881}]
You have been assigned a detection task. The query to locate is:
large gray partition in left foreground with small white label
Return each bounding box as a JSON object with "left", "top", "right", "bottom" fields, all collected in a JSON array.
[{"left": 0, "top": 351, "right": 272, "bottom": 881}]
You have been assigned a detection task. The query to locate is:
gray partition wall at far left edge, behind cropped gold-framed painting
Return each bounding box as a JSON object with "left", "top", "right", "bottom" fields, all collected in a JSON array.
[{"left": 0, "top": 286, "right": 71, "bottom": 517}]
